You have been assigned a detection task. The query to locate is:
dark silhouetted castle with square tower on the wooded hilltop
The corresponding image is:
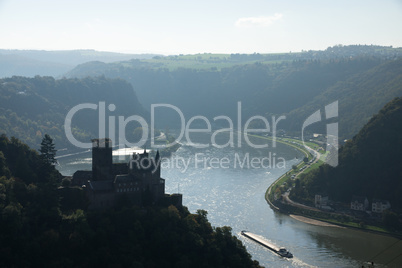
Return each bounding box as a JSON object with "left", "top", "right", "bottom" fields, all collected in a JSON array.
[{"left": 72, "top": 138, "right": 182, "bottom": 209}]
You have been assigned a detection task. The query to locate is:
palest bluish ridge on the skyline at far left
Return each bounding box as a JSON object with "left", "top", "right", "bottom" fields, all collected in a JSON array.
[{"left": 0, "top": 49, "right": 160, "bottom": 78}]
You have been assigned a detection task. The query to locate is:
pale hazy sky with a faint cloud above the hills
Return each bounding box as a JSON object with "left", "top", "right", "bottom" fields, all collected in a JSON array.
[{"left": 0, "top": 0, "right": 402, "bottom": 54}]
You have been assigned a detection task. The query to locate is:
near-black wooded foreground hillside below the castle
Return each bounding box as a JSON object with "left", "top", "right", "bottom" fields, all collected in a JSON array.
[{"left": 0, "top": 135, "right": 260, "bottom": 267}]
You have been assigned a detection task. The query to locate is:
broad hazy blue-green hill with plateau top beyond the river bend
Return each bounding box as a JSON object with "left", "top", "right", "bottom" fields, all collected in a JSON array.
[{"left": 69, "top": 46, "right": 402, "bottom": 138}]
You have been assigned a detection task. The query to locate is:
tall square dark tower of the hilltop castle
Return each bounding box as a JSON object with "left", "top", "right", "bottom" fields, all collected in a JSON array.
[{"left": 92, "top": 138, "right": 113, "bottom": 181}]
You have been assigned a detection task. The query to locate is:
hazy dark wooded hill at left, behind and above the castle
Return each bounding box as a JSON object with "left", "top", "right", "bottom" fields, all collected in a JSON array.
[{"left": 0, "top": 76, "right": 148, "bottom": 149}]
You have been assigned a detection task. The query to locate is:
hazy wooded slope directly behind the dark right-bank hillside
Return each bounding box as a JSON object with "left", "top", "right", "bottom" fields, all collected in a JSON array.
[{"left": 284, "top": 59, "right": 402, "bottom": 139}]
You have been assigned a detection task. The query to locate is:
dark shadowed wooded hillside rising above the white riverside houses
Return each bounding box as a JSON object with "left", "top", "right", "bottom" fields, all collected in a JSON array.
[{"left": 292, "top": 98, "right": 402, "bottom": 209}]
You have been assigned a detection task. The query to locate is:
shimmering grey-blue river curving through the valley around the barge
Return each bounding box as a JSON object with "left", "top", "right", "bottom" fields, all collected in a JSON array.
[{"left": 58, "top": 134, "right": 402, "bottom": 267}]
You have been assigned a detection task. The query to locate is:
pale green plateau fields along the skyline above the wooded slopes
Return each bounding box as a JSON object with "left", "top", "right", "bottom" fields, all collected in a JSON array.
[{"left": 67, "top": 45, "right": 402, "bottom": 74}]
